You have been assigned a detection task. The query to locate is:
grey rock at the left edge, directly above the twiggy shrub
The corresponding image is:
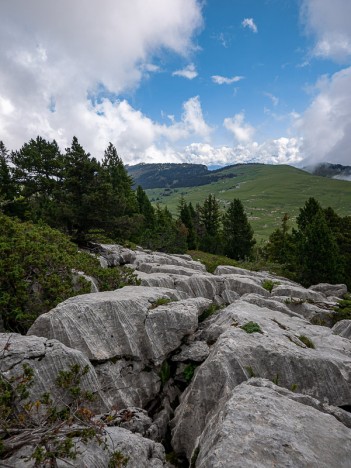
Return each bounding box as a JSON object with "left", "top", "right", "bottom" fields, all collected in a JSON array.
[{"left": 0, "top": 333, "right": 109, "bottom": 412}]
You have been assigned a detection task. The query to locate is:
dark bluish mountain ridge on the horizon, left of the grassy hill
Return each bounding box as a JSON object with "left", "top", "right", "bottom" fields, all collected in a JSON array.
[{"left": 126, "top": 163, "right": 235, "bottom": 189}]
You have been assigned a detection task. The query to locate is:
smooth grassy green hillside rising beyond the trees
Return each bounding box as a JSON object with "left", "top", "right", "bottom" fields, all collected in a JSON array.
[{"left": 146, "top": 164, "right": 351, "bottom": 241}]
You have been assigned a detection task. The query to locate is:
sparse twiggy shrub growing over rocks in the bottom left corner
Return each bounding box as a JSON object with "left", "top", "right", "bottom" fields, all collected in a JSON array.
[{"left": 0, "top": 358, "right": 120, "bottom": 467}]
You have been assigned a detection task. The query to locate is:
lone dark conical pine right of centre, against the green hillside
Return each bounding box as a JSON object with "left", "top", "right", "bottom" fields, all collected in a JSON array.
[{"left": 223, "top": 199, "right": 256, "bottom": 260}]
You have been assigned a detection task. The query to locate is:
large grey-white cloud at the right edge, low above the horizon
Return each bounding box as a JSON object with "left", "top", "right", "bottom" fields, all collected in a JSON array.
[{"left": 296, "top": 67, "right": 351, "bottom": 165}]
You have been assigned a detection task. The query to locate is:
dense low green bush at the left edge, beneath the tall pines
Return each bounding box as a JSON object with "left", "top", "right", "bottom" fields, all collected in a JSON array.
[{"left": 0, "top": 214, "right": 138, "bottom": 333}]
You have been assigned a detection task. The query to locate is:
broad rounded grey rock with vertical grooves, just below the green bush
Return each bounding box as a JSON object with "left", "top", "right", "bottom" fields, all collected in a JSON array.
[{"left": 28, "top": 286, "right": 185, "bottom": 361}]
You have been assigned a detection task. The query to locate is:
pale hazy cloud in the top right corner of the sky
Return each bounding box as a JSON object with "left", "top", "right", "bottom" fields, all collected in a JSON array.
[{"left": 301, "top": 0, "right": 351, "bottom": 62}]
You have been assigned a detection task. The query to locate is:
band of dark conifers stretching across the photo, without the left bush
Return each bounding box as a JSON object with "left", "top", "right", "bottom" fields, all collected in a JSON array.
[{"left": 0, "top": 136, "right": 351, "bottom": 287}]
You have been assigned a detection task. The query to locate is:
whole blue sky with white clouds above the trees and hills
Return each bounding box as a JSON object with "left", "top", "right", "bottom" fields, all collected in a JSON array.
[{"left": 0, "top": 0, "right": 351, "bottom": 166}]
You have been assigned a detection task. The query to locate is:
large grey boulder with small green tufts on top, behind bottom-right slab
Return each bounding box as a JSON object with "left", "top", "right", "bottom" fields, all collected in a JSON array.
[{"left": 172, "top": 301, "right": 351, "bottom": 457}]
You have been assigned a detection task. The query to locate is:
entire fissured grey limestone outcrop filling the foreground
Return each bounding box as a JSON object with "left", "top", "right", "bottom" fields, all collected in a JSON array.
[{"left": 0, "top": 244, "right": 351, "bottom": 468}]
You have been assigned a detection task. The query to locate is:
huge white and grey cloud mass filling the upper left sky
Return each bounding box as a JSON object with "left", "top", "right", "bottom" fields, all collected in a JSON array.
[{"left": 0, "top": 0, "right": 207, "bottom": 157}]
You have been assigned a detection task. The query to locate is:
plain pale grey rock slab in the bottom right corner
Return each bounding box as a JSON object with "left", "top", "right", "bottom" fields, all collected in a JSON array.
[{"left": 195, "top": 379, "right": 351, "bottom": 468}]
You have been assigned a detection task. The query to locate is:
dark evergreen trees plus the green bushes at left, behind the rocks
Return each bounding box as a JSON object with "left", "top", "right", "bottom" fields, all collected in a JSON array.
[{"left": 0, "top": 136, "right": 351, "bottom": 331}]
